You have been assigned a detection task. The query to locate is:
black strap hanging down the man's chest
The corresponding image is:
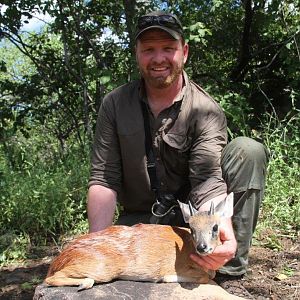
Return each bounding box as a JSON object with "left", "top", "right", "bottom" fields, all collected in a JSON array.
[{"left": 141, "top": 101, "right": 159, "bottom": 196}]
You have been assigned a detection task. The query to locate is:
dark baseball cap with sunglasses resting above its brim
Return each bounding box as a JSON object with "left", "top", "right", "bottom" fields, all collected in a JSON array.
[{"left": 135, "top": 10, "right": 183, "bottom": 40}]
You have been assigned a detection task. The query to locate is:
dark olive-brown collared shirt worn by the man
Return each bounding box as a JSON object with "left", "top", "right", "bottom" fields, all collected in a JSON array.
[{"left": 89, "top": 72, "right": 227, "bottom": 212}]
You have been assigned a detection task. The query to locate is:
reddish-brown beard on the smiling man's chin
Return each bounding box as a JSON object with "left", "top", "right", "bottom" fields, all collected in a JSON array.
[{"left": 140, "top": 61, "right": 184, "bottom": 89}]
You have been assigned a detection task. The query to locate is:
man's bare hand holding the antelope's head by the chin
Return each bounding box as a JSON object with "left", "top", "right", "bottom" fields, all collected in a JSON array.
[{"left": 191, "top": 219, "right": 237, "bottom": 270}]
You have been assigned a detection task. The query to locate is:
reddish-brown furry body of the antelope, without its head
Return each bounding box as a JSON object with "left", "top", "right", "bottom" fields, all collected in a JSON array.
[{"left": 45, "top": 224, "right": 209, "bottom": 288}]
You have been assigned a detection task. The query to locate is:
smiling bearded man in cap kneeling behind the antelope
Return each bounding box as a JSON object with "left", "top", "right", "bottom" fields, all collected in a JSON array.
[{"left": 88, "top": 11, "right": 267, "bottom": 298}]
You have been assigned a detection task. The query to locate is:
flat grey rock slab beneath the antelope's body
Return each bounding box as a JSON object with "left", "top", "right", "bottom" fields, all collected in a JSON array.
[{"left": 33, "top": 280, "right": 243, "bottom": 300}]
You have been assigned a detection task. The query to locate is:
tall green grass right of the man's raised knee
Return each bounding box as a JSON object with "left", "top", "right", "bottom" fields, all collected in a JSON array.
[{"left": 255, "top": 110, "right": 300, "bottom": 239}]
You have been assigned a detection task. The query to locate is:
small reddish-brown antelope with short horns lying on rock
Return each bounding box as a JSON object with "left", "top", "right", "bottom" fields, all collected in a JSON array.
[{"left": 45, "top": 193, "right": 233, "bottom": 291}]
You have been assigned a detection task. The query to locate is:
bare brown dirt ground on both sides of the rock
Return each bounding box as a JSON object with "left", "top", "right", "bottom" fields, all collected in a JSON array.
[{"left": 0, "top": 240, "right": 300, "bottom": 300}]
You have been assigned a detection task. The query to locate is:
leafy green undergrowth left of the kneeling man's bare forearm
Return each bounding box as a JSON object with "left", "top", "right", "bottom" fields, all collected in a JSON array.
[{"left": 0, "top": 127, "right": 89, "bottom": 240}]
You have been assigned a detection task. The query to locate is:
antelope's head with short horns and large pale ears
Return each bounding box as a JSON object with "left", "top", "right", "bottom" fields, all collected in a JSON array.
[{"left": 178, "top": 193, "right": 233, "bottom": 255}]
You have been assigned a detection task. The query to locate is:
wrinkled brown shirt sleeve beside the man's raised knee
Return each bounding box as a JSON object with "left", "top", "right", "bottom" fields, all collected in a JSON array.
[{"left": 189, "top": 101, "right": 227, "bottom": 201}]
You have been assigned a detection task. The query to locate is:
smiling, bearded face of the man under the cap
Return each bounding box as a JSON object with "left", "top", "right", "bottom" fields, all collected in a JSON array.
[{"left": 136, "top": 29, "right": 188, "bottom": 88}]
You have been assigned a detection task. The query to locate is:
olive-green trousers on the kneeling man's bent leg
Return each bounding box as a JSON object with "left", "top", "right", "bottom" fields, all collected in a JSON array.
[{"left": 116, "top": 137, "right": 269, "bottom": 275}]
